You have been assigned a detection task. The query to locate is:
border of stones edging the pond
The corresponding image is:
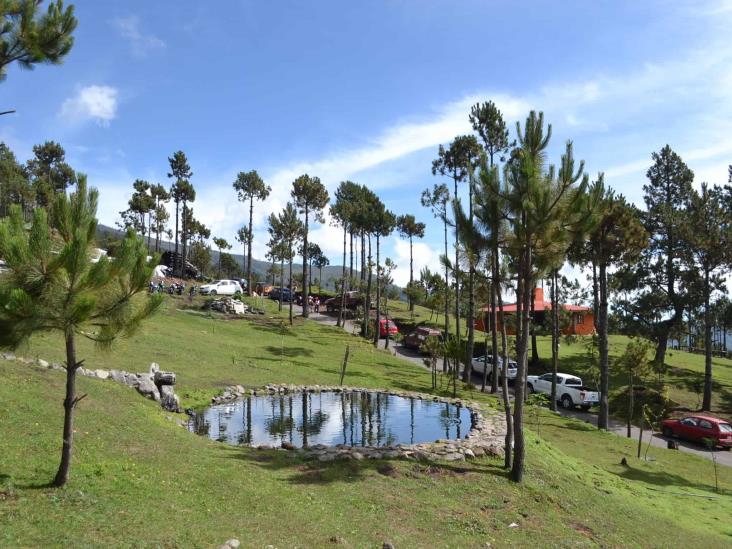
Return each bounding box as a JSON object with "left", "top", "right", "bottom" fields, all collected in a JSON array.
[{"left": 204, "top": 384, "right": 506, "bottom": 461}]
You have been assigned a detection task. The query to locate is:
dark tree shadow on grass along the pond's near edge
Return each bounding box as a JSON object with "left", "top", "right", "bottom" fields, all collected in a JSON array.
[{"left": 222, "top": 447, "right": 509, "bottom": 485}]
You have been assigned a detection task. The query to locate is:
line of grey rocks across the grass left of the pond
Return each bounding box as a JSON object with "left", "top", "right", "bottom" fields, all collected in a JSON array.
[{"left": 0, "top": 353, "right": 182, "bottom": 413}]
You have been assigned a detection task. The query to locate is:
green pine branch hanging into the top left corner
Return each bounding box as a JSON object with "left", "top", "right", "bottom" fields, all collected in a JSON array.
[{"left": 0, "top": 0, "right": 77, "bottom": 80}]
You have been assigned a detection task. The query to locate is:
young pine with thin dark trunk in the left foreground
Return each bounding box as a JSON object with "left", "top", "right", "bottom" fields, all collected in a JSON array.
[{"left": 0, "top": 178, "right": 162, "bottom": 486}]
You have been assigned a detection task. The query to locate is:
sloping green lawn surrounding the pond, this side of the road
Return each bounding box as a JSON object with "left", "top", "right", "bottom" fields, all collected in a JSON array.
[{"left": 0, "top": 299, "right": 732, "bottom": 548}]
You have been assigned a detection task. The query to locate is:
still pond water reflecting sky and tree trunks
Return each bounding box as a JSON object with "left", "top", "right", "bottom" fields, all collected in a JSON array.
[{"left": 188, "top": 392, "right": 471, "bottom": 447}]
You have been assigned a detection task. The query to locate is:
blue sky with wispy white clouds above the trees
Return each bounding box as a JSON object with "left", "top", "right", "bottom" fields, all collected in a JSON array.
[{"left": 0, "top": 0, "right": 732, "bottom": 283}]
